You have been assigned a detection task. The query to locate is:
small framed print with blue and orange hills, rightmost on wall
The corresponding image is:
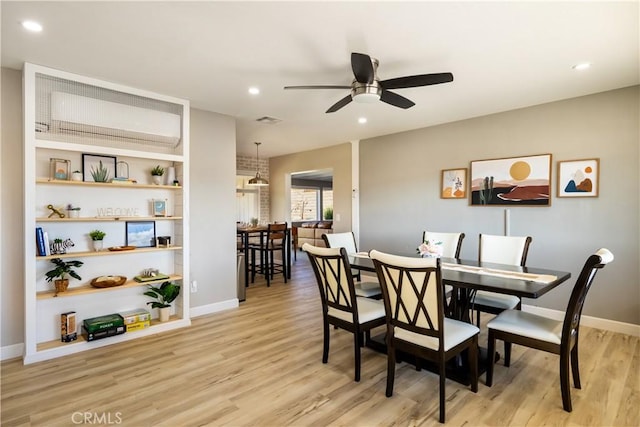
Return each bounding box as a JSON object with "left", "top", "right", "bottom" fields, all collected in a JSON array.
[{"left": 557, "top": 159, "right": 600, "bottom": 197}]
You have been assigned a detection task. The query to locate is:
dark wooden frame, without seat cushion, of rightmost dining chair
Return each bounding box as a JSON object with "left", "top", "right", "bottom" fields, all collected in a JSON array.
[{"left": 486, "top": 254, "right": 608, "bottom": 412}]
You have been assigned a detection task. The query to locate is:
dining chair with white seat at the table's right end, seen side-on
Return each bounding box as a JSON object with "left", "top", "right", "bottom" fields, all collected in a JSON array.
[{"left": 487, "top": 248, "right": 613, "bottom": 412}]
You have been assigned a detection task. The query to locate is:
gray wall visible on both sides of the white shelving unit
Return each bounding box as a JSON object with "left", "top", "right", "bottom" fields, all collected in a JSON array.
[{"left": 0, "top": 68, "right": 236, "bottom": 347}]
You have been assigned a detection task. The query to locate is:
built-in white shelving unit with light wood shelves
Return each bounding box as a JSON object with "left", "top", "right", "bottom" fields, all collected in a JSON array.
[{"left": 24, "top": 64, "right": 190, "bottom": 363}]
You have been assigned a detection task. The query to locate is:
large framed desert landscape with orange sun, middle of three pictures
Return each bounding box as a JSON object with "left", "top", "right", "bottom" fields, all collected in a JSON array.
[{"left": 471, "top": 154, "right": 551, "bottom": 206}]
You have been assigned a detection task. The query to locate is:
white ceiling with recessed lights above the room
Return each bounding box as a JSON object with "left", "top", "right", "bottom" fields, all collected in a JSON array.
[{"left": 0, "top": 1, "right": 640, "bottom": 158}]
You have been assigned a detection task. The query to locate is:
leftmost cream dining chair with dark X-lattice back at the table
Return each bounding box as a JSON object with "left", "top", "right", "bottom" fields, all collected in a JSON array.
[{"left": 302, "top": 243, "right": 385, "bottom": 381}]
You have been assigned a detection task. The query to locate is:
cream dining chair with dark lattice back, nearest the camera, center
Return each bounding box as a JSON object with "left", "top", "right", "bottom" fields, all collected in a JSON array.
[{"left": 369, "top": 250, "right": 480, "bottom": 423}]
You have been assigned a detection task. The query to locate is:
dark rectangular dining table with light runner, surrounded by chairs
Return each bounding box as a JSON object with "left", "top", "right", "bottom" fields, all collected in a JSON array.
[{"left": 349, "top": 252, "right": 571, "bottom": 384}]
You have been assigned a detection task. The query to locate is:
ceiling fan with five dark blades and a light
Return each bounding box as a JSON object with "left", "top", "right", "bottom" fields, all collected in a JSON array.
[{"left": 284, "top": 52, "right": 453, "bottom": 113}]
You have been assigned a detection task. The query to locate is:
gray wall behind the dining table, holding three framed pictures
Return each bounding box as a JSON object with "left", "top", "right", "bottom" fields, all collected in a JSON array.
[{"left": 360, "top": 86, "right": 640, "bottom": 324}]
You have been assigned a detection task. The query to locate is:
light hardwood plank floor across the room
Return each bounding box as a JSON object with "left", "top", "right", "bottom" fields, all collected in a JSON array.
[{"left": 1, "top": 254, "right": 640, "bottom": 426}]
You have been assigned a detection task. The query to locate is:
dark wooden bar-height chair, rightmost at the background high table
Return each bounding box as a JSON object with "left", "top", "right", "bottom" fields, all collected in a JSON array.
[{"left": 249, "top": 222, "right": 287, "bottom": 286}]
